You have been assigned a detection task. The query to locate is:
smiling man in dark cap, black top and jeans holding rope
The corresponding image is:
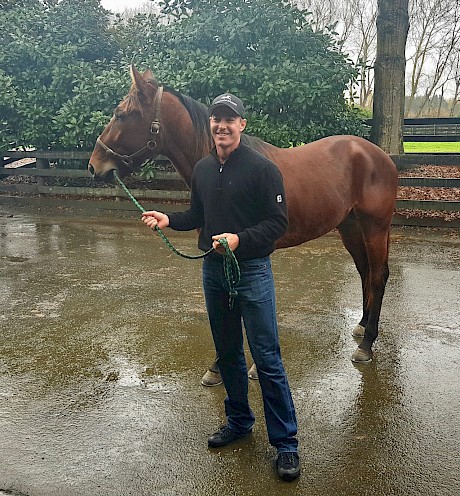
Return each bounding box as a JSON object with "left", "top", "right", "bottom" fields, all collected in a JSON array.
[{"left": 143, "top": 93, "right": 300, "bottom": 481}]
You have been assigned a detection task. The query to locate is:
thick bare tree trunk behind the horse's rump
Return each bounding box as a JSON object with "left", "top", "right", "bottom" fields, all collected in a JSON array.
[{"left": 370, "top": 0, "right": 409, "bottom": 154}]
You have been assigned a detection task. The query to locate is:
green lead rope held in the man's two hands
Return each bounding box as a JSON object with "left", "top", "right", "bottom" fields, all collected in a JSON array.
[{"left": 113, "top": 170, "right": 241, "bottom": 309}]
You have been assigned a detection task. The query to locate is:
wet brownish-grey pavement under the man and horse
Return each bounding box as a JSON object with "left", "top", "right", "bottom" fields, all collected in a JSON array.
[{"left": 0, "top": 197, "right": 460, "bottom": 496}]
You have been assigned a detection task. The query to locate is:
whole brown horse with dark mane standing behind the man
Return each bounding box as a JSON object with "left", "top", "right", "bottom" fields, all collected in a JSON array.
[{"left": 89, "top": 67, "right": 398, "bottom": 362}]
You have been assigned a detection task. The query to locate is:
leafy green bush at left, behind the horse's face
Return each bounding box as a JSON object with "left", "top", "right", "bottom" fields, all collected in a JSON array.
[{"left": 0, "top": 0, "right": 123, "bottom": 149}]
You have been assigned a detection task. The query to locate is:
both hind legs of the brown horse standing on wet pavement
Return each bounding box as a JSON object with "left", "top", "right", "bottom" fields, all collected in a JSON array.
[{"left": 338, "top": 212, "right": 389, "bottom": 362}]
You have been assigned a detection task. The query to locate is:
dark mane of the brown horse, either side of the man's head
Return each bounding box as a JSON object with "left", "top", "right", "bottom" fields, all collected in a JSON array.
[{"left": 165, "top": 86, "right": 269, "bottom": 156}]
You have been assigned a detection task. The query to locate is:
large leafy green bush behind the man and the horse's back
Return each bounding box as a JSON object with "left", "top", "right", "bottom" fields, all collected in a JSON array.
[{"left": 125, "top": 0, "right": 363, "bottom": 146}]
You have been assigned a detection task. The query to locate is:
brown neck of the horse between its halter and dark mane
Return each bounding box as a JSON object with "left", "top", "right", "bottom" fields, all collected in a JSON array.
[{"left": 159, "top": 92, "right": 211, "bottom": 187}]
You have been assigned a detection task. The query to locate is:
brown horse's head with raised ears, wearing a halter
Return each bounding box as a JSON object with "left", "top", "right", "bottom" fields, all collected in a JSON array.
[{"left": 88, "top": 66, "right": 163, "bottom": 181}]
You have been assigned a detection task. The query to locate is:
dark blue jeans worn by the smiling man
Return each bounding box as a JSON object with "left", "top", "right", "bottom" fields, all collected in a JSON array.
[{"left": 203, "top": 257, "right": 297, "bottom": 453}]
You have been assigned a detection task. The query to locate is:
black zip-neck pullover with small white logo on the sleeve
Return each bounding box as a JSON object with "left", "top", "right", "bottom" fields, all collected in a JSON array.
[{"left": 168, "top": 143, "right": 288, "bottom": 260}]
